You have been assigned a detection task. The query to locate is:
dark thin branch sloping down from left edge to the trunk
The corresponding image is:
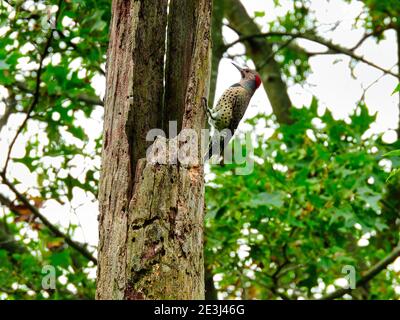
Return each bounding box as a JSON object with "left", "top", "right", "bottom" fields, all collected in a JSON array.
[{"left": 0, "top": 172, "right": 97, "bottom": 264}]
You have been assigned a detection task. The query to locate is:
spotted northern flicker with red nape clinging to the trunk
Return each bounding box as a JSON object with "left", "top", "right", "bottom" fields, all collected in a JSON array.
[{"left": 205, "top": 62, "right": 261, "bottom": 160}]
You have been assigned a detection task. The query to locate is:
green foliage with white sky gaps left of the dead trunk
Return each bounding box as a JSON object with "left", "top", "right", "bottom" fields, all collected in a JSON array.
[{"left": 0, "top": 0, "right": 110, "bottom": 299}]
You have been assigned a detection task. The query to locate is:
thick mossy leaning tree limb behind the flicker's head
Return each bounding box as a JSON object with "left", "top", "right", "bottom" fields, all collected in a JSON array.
[{"left": 225, "top": 0, "right": 292, "bottom": 124}]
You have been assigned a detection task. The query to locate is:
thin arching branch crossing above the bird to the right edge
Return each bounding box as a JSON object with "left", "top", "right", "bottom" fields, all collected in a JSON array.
[{"left": 225, "top": 31, "right": 400, "bottom": 78}]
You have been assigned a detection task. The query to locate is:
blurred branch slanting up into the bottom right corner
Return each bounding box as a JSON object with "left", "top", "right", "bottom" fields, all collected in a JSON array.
[{"left": 320, "top": 245, "right": 400, "bottom": 300}]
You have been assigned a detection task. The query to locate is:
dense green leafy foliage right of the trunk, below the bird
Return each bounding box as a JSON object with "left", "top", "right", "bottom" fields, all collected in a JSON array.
[{"left": 206, "top": 101, "right": 399, "bottom": 299}]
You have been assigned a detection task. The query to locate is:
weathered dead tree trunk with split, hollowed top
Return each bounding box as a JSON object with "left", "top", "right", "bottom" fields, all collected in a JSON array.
[{"left": 96, "top": 0, "right": 211, "bottom": 299}]
